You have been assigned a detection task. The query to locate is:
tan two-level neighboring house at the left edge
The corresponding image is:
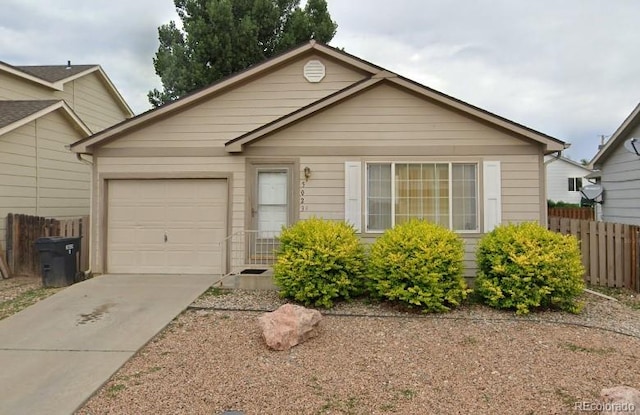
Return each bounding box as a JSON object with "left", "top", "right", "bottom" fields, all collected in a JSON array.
[{"left": 0, "top": 62, "right": 133, "bottom": 247}]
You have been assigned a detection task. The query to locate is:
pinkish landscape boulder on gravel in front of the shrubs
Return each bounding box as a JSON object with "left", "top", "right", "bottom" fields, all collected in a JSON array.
[{"left": 258, "top": 304, "right": 322, "bottom": 350}]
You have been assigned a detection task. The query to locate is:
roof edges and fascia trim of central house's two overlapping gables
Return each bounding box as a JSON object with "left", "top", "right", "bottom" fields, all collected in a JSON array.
[{"left": 71, "top": 40, "right": 568, "bottom": 153}]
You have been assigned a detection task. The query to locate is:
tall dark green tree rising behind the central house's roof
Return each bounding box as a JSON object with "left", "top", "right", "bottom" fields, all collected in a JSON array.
[{"left": 148, "top": 0, "right": 337, "bottom": 107}]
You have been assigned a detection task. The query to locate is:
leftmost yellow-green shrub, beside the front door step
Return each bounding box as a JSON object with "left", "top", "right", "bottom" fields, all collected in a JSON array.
[{"left": 274, "top": 218, "right": 365, "bottom": 308}]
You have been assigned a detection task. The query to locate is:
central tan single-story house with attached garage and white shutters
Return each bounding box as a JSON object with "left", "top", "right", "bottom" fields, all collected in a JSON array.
[{"left": 71, "top": 41, "right": 566, "bottom": 276}]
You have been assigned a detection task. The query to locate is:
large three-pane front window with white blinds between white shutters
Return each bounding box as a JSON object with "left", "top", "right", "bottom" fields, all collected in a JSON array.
[{"left": 367, "top": 163, "right": 479, "bottom": 232}]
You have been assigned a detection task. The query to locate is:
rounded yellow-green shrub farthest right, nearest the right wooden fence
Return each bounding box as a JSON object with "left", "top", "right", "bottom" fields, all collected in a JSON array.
[{"left": 475, "top": 223, "right": 584, "bottom": 314}]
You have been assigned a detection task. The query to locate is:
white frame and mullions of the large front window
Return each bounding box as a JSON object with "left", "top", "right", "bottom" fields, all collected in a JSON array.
[{"left": 362, "top": 160, "right": 482, "bottom": 235}]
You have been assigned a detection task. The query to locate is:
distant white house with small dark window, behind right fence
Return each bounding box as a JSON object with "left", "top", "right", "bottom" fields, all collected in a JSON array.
[{"left": 544, "top": 154, "right": 593, "bottom": 204}]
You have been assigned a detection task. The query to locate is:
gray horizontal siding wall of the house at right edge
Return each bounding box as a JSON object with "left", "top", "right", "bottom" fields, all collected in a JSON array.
[{"left": 601, "top": 126, "right": 640, "bottom": 225}]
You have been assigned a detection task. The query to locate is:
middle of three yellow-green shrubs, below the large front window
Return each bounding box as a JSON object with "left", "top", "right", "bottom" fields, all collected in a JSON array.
[{"left": 368, "top": 220, "right": 470, "bottom": 312}]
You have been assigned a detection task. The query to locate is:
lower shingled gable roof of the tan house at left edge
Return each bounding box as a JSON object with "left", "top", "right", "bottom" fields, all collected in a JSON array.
[{"left": 0, "top": 100, "right": 91, "bottom": 137}]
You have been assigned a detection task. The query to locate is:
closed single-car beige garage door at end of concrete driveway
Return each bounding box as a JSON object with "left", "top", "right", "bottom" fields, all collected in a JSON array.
[{"left": 107, "top": 179, "right": 227, "bottom": 274}]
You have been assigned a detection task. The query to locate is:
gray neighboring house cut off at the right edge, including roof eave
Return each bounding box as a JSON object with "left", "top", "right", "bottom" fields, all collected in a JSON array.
[{"left": 590, "top": 104, "right": 640, "bottom": 225}]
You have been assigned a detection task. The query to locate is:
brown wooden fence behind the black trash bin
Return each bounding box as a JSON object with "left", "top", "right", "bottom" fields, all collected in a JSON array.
[{"left": 6, "top": 213, "right": 89, "bottom": 276}]
